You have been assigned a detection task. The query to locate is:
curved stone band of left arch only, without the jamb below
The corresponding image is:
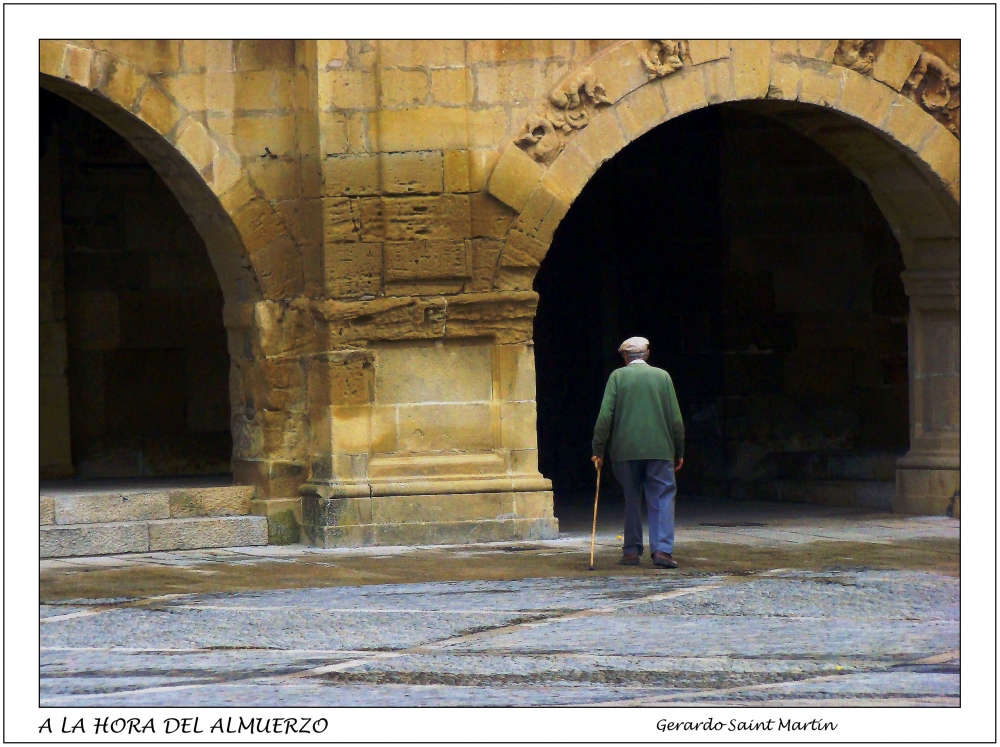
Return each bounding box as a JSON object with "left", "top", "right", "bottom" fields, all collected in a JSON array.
[{"left": 40, "top": 40, "right": 303, "bottom": 304}]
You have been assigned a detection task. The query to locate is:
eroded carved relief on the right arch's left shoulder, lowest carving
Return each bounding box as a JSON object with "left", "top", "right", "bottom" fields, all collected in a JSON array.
[{"left": 514, "top": 68, "right": 611, "bottom": 163}]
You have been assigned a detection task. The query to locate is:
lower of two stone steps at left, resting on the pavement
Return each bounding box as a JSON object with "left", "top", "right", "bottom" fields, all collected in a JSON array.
[{"left": 39, "top": 516, "right": 267, "bottom": 558}]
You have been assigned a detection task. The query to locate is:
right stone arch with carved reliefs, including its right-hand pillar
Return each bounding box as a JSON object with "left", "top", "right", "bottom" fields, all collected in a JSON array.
[{"left": 487, "top": 41, "right": 960, "bottom": 513}]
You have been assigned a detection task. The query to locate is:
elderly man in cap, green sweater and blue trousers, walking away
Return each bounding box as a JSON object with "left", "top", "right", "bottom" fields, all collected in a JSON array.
[{"left": 591, "top": 337, "right": 684, "bottom": 568}]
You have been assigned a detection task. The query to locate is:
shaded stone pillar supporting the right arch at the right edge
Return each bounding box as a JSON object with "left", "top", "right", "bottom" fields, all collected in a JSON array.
[{"left": 892, "top": 270, "right": 961, "bottom": 517}]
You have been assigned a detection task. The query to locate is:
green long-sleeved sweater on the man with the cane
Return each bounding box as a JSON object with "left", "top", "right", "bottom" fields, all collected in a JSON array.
[{"left": 593, "top": 361, "right": 684, "bottom": 462}]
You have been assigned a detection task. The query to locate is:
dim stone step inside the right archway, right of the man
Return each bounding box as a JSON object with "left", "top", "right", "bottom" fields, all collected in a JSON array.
[{"left": 736, "top": 480, "right": 896, "bottom": 511}]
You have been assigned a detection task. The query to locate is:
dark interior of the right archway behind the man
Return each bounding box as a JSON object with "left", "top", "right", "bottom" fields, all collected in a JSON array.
[{"left": 534, "top": 105, "right": 909, "bottom": 510}]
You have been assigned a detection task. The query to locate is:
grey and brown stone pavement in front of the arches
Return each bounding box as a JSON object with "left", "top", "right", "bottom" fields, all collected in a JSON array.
[{"left": 41, "top": 506, "right": 960, "bottom": 706}]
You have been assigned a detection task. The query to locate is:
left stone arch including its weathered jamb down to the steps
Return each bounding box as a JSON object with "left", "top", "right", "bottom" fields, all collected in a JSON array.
[{"left": 39, "top": 41, "right": 304, "bottom": 498}]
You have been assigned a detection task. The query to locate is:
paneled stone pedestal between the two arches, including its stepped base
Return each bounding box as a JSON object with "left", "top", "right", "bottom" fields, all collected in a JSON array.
[{"left": 301, "top": 340, "right": 558, "bottom": 547}]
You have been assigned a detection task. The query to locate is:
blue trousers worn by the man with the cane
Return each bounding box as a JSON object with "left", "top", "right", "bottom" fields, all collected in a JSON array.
[{"left": 611, "top": 459, "right": 677, "bottom": 555}]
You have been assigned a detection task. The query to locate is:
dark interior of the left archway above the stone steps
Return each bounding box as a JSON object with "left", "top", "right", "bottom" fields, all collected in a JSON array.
[{"left": 40, "top": 90, "right": 232, "bottom": 478}]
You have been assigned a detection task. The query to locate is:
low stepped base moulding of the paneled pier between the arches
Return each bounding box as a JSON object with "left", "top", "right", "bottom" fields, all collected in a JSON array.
[{"left": 302, "top": 486, "right": 559, "bottom": 547}]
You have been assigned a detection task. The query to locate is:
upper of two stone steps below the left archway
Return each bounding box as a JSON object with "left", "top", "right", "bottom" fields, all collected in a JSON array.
[{"left": 39, "top": 485, "right": 254, "bottom": 526}]
